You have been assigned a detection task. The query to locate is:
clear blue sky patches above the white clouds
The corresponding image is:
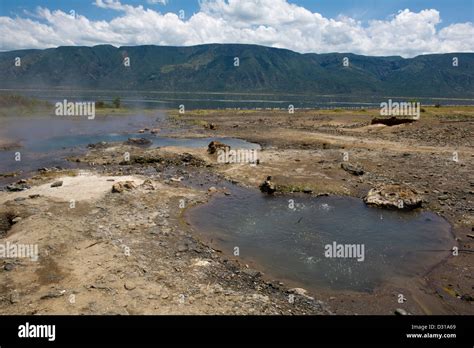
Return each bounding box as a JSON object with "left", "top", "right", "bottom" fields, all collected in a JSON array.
[{"left": 0, "top": 0, "right": 474, "bottom": 26}]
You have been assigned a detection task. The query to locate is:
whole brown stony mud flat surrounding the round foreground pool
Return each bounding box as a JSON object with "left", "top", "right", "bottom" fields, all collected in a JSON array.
[{"left": 0, "top": 108, "right": 474, "bottom": 314}]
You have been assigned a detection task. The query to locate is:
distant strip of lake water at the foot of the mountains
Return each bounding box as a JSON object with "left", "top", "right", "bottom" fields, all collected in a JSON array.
[{"left": 0, "top": 89, "right": 474, "bottom": 110}]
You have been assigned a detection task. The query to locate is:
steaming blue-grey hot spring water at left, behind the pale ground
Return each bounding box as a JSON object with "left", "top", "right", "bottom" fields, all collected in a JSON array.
[{"left": 0, "top": 111, "right": 260, "bottom": 175}]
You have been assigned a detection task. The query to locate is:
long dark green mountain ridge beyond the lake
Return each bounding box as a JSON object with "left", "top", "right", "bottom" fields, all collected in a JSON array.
[{"left": 0, "top": 44, "right": 474, "bottom": 98}]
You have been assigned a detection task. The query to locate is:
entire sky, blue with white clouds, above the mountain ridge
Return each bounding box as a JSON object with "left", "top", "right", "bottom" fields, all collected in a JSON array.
[{"left": 0, "top": 0, "right": 474, "bottom": 57}]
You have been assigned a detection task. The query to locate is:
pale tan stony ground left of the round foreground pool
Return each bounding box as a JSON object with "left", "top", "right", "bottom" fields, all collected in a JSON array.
[{"left": 0, "top": 159, "right": 331, "bottom": 315}]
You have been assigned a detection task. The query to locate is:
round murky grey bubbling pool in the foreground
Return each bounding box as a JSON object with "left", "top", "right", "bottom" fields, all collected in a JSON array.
[{"left": 187, "top": 189, "right": 454, "bottom": 291}]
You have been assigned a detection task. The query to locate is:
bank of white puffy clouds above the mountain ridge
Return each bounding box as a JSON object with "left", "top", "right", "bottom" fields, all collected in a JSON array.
[{"left": 0, "top": 0, "right": 474, "bottom": 57}]
